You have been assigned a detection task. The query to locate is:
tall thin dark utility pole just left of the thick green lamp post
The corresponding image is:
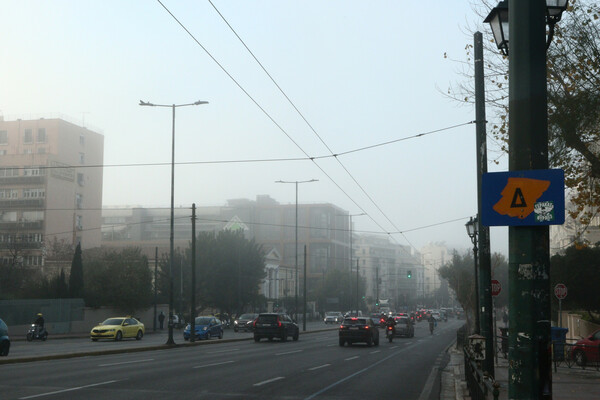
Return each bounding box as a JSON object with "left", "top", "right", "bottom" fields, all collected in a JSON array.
[{"left": 474, "top": 32, "right": 496, "bottom": 377}]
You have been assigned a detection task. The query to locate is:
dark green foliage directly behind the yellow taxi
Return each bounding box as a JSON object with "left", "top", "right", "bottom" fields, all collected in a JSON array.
[{"left": 83, "top": 248, "right": 152, "bottom": 314}]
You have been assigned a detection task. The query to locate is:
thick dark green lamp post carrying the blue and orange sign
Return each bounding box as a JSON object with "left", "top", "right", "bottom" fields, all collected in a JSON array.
[{"left": 484, "top": 0, "right": 568, "bottom": 400}]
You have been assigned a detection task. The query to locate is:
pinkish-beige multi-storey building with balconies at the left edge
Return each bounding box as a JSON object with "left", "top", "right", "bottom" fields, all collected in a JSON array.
[{"left": 0, "top": 117, "right": 104, "bottom": 267}]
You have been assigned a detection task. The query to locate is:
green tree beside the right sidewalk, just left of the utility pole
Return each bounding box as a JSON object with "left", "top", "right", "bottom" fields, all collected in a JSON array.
[{"left": 438, "top": 250, "right": 476, "bottom": 330}]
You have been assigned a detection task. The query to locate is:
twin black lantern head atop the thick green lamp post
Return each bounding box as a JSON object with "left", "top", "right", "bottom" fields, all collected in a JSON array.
[{"left": 483, "top": 0, "right": 569, "bottom": 56}]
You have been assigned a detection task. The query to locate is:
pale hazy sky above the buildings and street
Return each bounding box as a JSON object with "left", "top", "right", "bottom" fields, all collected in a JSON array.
[{"left": 0, "top": 0, "right": 507, "bottom": 254}]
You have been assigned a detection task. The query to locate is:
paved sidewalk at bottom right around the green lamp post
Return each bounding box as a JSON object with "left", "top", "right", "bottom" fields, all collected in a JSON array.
[{"left": 440, "top": 345, "right": 600, "bottom": 400}]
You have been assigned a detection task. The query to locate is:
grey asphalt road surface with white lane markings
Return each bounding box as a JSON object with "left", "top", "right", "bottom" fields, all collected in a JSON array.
[{"left": 0, "top": 319, "right": 464, "bottom": 400}]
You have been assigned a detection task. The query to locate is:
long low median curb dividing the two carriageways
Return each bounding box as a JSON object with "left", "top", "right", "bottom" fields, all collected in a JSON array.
[{"left": 0, "top": 328, "right": 332, "bottom": 365}]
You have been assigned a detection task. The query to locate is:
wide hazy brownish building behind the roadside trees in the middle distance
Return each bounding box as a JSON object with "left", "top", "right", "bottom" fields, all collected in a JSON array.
[{"left": 102, "top": 195, "right": 350, "bottom": 298}]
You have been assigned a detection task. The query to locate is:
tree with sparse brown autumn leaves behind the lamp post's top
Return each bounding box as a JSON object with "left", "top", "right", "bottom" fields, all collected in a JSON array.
[{"left": 448, "top": 0, "right": 600, "bottom": 225}]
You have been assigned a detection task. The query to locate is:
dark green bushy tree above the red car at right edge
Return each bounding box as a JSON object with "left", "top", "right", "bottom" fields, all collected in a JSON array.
[{"left": 550, "top": 242, "right": 600, "bottom": 323}]
